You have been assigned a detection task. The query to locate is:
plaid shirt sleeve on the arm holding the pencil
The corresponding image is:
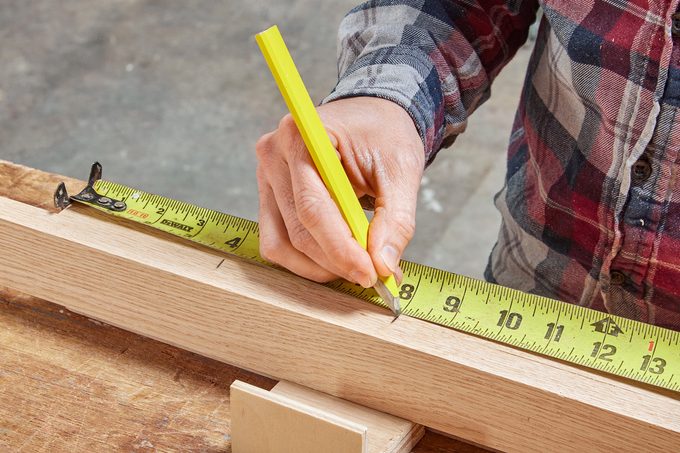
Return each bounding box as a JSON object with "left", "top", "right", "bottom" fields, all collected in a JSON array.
[{"left": 324, "top": 0, "right": 538, "bottom": 163}]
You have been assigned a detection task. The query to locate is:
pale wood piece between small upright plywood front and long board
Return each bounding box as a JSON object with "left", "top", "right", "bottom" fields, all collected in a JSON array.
[{"left": 270, "top": 381, "right": 425, "bottom": 453}]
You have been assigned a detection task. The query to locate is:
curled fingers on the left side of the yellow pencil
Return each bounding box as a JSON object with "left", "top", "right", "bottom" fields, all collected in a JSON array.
[{"left": 257, "top": 117, "right": 377, "bottom": 287}]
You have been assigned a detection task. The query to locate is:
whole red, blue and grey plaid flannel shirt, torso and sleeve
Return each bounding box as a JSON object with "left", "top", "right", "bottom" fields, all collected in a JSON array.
[{"left": 324, "top": 0, "right": 680, "bottom": 330}]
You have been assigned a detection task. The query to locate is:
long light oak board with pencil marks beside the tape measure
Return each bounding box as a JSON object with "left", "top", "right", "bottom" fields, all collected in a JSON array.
[{"left": 0, "top": 198, "right": 680, "bottom": 452}]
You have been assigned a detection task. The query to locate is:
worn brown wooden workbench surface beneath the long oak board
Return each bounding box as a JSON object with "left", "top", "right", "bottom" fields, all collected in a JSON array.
[{"left": 0, "top": 161, "right": 482, "bottom": 453}]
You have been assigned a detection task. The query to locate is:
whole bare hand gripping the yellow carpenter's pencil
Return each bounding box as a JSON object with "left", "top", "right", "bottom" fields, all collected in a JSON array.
[{"left": 256, "top": 97, "right": 425, "bottom": 288}]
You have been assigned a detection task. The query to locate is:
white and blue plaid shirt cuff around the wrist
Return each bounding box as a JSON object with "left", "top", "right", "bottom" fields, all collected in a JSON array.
[{"left": 322, "top": 46, "right": 444, "bottom": 164}]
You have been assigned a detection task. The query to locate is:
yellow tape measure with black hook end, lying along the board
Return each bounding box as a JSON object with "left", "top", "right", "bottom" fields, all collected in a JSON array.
[{"left": 55, "top": 164, "right": 680, "bottom": 392}]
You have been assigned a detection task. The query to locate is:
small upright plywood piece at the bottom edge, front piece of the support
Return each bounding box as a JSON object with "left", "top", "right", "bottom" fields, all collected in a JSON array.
[{"left": 231, "top": 381, "right": 367, "bottom": 453}]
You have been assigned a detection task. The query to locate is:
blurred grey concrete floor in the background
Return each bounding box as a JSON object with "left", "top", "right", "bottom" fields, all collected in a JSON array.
[{"left": 0, "top": 0, "right": 529, "bottom": 277}]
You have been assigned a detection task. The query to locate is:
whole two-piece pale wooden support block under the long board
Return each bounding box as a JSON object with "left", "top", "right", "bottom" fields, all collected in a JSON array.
[{"left": 231, "top": 381, "right": 425, "bottom": 453}]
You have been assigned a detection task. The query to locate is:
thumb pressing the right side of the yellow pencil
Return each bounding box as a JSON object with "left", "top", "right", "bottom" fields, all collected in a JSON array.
[{"left": 368, "top": 178, "right": 419, "bottom": 281}]
